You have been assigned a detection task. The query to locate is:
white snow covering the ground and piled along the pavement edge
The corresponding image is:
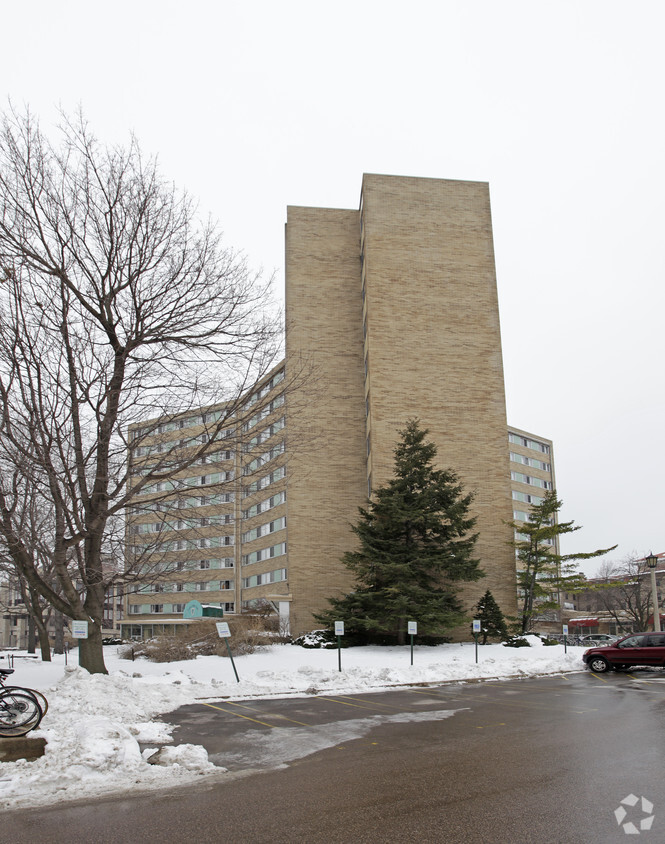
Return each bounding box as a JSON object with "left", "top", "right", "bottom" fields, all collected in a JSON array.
[{"left": 0, "top": 637, "right": 583, "bottom": 810}]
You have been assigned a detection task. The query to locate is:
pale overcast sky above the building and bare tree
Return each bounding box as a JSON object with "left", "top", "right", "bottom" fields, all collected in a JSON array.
[{"left": 0, "top": 0, "right": 665, "bottom": 571}]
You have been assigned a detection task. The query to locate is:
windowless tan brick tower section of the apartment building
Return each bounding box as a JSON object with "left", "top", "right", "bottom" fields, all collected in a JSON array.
[{"left": 286, "top": 175, "right": 515, "bottom": 629}]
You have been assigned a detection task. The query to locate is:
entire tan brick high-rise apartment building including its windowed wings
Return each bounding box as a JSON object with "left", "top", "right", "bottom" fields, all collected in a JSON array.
[{"left": 125, "top": 175, "right": 553, "bottom": 635}]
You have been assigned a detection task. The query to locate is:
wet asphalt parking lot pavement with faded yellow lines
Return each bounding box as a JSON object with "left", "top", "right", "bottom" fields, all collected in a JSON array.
[{"left": 5, "top": 670, "right": 665, "bottom": 844}]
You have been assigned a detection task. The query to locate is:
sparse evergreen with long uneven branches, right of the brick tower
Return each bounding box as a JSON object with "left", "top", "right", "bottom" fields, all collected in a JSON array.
[{"left": 509, "top": 490, "right": 616, "bottom": 633}]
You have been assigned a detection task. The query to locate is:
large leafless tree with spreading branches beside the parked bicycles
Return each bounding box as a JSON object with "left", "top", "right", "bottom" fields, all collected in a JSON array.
[{"left": 0, "top": 111, "right": 281, "bottom": 672}]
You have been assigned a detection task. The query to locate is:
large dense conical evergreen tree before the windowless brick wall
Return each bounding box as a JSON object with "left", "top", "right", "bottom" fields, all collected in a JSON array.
[{"left": 317, "top": 420, "right": 484, "bottom": 644}]
